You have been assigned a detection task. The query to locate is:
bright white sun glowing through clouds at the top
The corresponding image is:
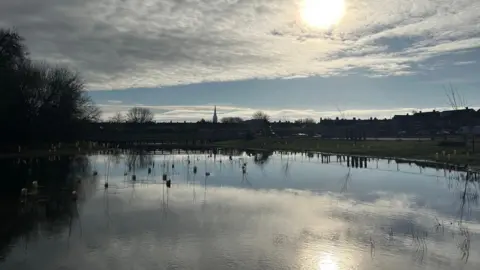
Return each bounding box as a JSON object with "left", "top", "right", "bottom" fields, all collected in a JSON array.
[{"left": 301, "top": 0, "right": 345, "bottom": 29}]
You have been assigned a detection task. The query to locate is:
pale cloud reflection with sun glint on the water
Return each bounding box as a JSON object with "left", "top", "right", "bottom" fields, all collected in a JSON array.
[{"left": 54, "top": 184, "right": 479, "bottom": 270}]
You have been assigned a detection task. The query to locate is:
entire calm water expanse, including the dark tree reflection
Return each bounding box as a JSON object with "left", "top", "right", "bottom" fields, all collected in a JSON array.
[{"left": 0, "top": 152, "right": 480, "bottom": 270}]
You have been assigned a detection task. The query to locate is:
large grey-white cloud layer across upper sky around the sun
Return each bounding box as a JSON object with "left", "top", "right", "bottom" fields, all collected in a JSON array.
[{"left": 0, "top": 0, "right": 480, "bottom": 89}]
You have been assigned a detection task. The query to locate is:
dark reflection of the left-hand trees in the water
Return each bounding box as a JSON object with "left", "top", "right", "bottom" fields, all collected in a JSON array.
[{"left": 0, "top": 156, "right": 94, "bottom": 260}]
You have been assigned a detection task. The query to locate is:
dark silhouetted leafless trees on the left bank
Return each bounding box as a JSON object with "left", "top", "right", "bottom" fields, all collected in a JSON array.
[{"left": 0, "top": 29, "right": 100, "bottom": 144}]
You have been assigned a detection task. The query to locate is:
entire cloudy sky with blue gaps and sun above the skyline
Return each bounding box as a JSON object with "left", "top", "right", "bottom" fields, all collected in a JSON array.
[{"left": 0, "top": 0, "right": 480, "bottom": 121}]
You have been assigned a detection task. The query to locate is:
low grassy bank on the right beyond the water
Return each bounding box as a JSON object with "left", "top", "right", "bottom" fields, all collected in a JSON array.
[{"left": 216, "top": 138, "right": 480, "bottom": 167}]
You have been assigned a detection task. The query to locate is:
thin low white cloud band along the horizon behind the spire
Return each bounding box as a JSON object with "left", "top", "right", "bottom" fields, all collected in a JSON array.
[{"left": 99, "top": 104, "right": 476, "bottom": 122}]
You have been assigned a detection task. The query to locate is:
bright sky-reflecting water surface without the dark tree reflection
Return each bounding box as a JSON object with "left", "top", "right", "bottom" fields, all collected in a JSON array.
[{"left": 0, "top": 155, "right": 480, "bottom": 270}]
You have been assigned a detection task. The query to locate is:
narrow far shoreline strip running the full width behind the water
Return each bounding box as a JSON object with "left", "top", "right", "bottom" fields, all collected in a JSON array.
[{"left": 0, "top": 138, "right": 480, "bottom": 172}]
